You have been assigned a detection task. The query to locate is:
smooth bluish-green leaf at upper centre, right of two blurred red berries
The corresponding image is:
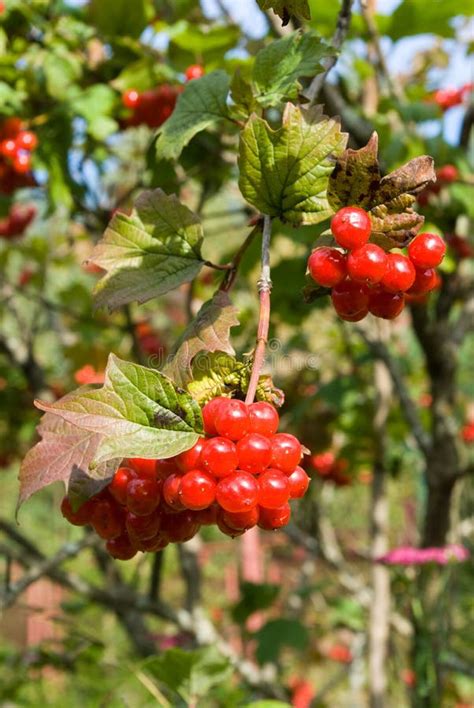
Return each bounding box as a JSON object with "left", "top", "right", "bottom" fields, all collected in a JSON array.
[{"left": 156, "top": 71, "right": 230, "bottom": 159}]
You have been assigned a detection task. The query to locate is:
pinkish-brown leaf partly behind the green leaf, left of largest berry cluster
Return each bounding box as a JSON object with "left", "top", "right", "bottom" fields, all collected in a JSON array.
[{"left": 18, "top": 406, "right": 120, "bottom": 507}]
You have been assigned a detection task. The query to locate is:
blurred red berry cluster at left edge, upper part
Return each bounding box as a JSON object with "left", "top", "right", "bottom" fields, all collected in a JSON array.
[{"left": 0, "top": 118, "right": 38, "bottom": 194}]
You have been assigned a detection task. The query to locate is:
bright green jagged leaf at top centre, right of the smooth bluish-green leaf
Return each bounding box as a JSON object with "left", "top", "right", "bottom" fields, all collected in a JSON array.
[{"left": 253, "top": 32, "right": 335, "bottom": 107}]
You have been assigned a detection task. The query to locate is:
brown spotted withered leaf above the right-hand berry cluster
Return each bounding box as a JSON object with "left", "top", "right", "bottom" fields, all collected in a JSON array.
[{"left": 328, "top": 133, "right": 436, "bottom": 248}]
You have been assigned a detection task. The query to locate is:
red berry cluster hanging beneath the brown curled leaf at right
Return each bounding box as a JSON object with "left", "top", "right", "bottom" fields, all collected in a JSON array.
[{"left": 308, "top": 206, "right": 446, "bottom": 322}]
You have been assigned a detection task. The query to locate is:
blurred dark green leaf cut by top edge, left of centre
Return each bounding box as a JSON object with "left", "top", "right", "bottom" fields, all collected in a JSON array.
[{"left": 89, "top": 0, "right": 149, "bottom": 37}]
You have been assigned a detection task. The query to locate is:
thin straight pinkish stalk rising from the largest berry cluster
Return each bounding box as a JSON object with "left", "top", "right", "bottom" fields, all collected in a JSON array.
[{"left": 245, "top": 214, "right": 272, "bottom": 405}]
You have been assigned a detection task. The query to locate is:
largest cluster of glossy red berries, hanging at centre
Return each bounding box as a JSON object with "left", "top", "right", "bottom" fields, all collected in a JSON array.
[{"left": 61, "top": 397, "right": 310, "bottom": 560}]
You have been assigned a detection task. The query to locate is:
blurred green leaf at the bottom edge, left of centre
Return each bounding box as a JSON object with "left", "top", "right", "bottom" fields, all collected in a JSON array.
[{"left": 143, "top": 646, "right": 233, "bottom": 704}]
